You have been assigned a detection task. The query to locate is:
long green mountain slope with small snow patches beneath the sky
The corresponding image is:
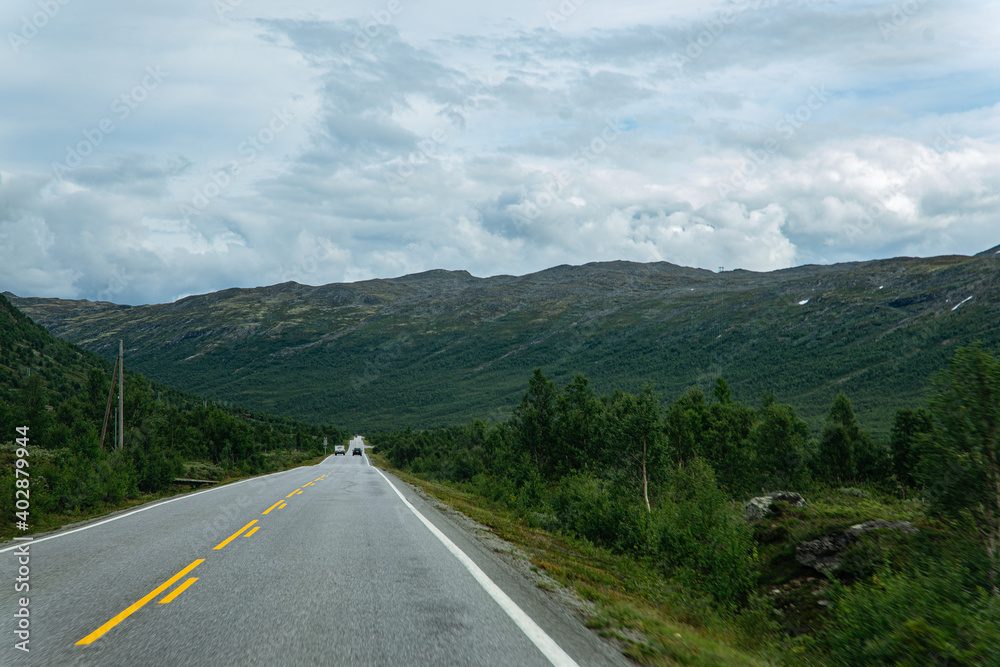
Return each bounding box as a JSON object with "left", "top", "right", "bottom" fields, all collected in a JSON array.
[{"left": 11, "top": 253, "right": 1000, "bottom": 436}]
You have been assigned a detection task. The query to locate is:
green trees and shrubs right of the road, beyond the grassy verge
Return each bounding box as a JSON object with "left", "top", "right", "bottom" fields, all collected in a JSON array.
[{"left": 371, "top": 346, "right": 1000, "bottom": 665}]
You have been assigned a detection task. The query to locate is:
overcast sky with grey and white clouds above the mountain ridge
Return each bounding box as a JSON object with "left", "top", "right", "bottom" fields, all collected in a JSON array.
[{"left": 0, "top": 0, "right": 1000, "bottom": 304}]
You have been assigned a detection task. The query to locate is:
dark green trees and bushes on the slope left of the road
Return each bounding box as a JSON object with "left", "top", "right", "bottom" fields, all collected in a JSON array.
[{"left": 0, "top": 296, "right": 349, "bottom": 536}]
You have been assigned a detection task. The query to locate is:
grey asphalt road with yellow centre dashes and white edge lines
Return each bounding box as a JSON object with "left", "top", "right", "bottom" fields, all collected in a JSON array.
[{"left": 0, "top": 448, "right": 628, "bottom": 667}]
